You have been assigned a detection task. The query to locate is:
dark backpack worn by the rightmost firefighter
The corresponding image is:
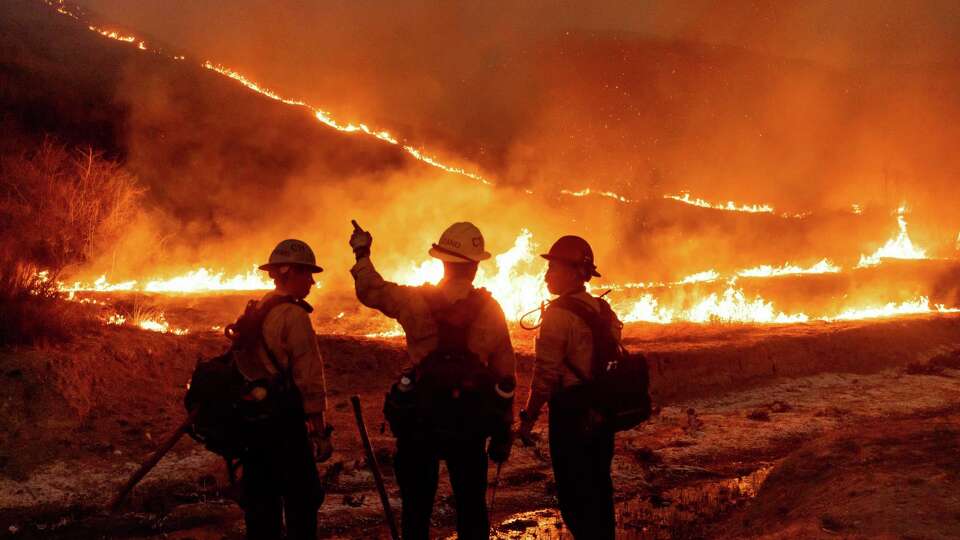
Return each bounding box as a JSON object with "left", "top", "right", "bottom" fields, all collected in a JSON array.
[{"left": 551, "top": 296, "right": 651, "bottom": 431}]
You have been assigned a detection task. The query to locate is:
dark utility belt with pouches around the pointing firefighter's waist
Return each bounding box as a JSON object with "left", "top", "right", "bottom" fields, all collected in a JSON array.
[{"left": 383, "top": 370, "right": 515, "bottom": 443}]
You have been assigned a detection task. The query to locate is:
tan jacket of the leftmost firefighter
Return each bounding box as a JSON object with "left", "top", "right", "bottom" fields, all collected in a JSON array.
[{"left": 241, "top": 291, "right": 327, "bottom": 416}]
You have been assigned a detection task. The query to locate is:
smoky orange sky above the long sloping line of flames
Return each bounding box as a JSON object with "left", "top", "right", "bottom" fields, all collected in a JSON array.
[{"left": 75, "top": 0, "right": 960, "bottom": 211}]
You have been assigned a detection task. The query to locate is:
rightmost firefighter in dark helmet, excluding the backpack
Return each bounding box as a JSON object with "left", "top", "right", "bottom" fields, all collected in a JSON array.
[{"left": 518, "top": 236, "right": 620, "bottom": 540}]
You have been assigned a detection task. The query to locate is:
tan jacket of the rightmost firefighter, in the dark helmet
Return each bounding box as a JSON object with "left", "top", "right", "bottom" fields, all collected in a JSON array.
[{"left": 526, "top": 291, "right": 620, "bottom": 420}]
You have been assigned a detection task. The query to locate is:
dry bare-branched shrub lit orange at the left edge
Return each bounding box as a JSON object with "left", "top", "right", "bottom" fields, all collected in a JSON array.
[{"left": 0, "top": 140, "right": 143, "bottom": 343}]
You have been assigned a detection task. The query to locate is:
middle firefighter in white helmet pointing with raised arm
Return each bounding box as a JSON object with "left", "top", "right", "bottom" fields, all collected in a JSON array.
[{"left": 350, "top": 222, "right": 516, "bottom": 540}]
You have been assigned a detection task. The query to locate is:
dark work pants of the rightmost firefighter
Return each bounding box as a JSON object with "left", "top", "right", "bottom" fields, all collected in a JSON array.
[{"left": 549, "top": 407, "right": 616, "bottom": 540}]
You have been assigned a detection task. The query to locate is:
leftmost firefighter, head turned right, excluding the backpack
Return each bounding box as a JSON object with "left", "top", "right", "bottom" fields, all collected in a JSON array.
[{"left": 240, "top": 240, "right": 333, "bottom": 540}]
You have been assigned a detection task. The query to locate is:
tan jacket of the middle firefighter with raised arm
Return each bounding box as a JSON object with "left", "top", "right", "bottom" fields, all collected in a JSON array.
[{"left": 350, "top": 257, "right": 516, "bottom": 380}]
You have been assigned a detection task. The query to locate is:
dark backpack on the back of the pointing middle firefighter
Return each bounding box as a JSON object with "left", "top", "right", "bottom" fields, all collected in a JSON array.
[{"left": 404, "top": 289, "right": 496, "bottom": 441}]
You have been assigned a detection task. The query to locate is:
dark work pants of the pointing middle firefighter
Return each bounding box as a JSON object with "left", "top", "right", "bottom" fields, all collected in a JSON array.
[{"left": 394, "top": 435, "right": 490, "bottom": 540}]
